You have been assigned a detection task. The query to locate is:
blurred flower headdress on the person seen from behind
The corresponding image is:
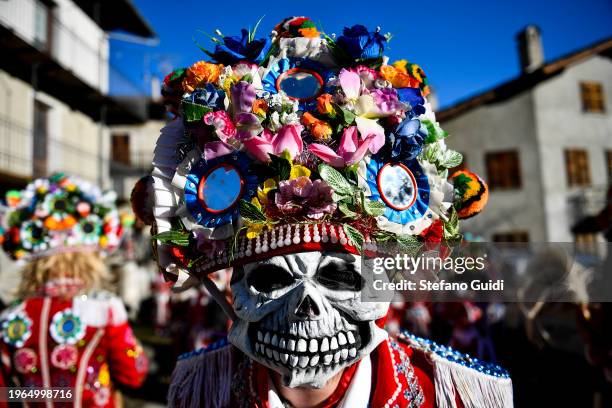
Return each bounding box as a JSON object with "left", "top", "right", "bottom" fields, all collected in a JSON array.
[{"left": 2, "top": 173, "right": 122, "bottom": 261}]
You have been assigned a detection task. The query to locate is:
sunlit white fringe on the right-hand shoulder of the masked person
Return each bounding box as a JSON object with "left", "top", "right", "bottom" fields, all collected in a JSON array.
[{"left": 431, "top": 354, "right": 514, "bottom": 408}]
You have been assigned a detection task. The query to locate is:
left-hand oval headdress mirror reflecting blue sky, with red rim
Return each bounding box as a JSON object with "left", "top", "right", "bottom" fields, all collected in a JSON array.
[{"left": 198, "top": 164, "right": 244, "bottom": 213}]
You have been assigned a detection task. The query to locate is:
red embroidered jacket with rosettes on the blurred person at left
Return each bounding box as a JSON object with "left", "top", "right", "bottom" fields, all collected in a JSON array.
[{"left": 0, "top": 285, "right": 148, "bottom": 407}]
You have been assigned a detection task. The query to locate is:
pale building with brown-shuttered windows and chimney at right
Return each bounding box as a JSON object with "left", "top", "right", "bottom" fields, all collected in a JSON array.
[{"left": 437, "top": 26, "right": 612, "bottom": 243}]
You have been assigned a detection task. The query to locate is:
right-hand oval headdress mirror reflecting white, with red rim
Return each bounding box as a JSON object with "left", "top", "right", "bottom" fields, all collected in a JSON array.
[{"left": 376, "top": 163, "right": 417, "bottom": 211}]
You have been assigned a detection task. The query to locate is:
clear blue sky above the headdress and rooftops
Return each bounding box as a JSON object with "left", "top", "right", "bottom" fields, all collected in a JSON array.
[{"left": 112, "top": 0, "right": 612, "bottom": 106}]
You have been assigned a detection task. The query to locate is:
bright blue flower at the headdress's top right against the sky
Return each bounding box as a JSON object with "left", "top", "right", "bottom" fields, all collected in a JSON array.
[{"left": 336, "top": 24, "right": 387, "bottom": 60}]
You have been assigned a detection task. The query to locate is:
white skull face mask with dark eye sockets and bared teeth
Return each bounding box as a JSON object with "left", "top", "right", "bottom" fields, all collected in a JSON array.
[{"left": 229, "top": 252, "right": 389, "bottom": 388}]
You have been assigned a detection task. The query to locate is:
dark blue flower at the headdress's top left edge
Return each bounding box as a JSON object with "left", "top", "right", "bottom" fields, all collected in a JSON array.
[{"left": 212, "top": 28, "right": 272, "bottom": 65}]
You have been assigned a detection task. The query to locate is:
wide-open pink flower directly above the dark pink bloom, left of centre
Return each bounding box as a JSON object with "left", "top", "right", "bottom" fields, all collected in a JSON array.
[{"left": 242, "top": 125, "right": 304, "bottom": 162}]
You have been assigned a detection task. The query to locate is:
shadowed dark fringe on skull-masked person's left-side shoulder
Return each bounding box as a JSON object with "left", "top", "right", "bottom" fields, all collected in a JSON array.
[{"left": 168, "top": 340, "right": 232, "bottom": 408}]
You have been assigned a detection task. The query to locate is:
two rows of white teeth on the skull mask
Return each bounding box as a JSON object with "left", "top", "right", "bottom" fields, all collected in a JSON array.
[{"left": 255, "top": 330, "right": 360, "bottom": 370}]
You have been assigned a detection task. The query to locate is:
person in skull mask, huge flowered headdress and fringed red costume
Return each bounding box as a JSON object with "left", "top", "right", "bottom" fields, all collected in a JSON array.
[{"left": 136, "top": 17, "right": 512, "bottom": 408}]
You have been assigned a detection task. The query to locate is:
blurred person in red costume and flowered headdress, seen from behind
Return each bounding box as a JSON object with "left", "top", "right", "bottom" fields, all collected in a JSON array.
[{"left": 0, "top": 173, "right": 148, "bottom": 407}]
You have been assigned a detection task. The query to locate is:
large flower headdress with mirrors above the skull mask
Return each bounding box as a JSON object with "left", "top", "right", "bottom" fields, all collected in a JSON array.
[{"left": 147, "top": 17, "right": 486, "bottom": 288}]
